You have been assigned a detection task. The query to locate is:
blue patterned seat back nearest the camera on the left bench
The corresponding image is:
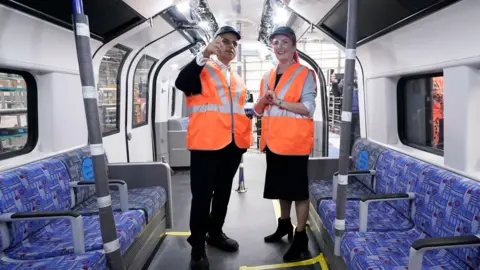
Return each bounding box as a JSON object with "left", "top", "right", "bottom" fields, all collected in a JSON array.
[{"left": 0, "top": 158, "right": 72, "bottom": 248}]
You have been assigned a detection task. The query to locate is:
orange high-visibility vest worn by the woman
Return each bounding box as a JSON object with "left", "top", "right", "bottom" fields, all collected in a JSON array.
[{"left": 260, "top": 63, "right": 314, "bottom": 156}]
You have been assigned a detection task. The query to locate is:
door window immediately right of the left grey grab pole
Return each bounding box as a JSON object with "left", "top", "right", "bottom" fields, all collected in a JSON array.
[{"left": 97, "top": 45, "right": 131, "bottom": 137}]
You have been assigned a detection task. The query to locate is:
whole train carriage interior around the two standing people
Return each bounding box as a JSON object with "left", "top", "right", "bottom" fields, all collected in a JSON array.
[{"left": 0, "top": 0, "right": 480, "bottom": 270}]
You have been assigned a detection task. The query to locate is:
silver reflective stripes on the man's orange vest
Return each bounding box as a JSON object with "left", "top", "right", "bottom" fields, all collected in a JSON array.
[{"left": 187, "top": 64, "right": 245, "bottom": 118}]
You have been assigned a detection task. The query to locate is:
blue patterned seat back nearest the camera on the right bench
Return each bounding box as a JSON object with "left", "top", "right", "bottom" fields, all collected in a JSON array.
[{"left": 414, "top": 166, "right": 480, "bottom": 269}]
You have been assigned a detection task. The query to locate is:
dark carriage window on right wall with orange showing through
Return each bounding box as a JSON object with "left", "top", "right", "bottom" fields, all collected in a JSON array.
[{"left": 398, "top": 74, "right": 444, "bottom": 155}]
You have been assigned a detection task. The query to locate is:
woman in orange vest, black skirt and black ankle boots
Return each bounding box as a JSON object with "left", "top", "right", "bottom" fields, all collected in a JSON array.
[{"left": 254, "top": 27, "right": 316, "bottom": 261}]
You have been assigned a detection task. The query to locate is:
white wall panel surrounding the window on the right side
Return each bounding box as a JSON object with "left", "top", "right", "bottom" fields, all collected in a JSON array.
[{"left": 357, "top": 0, "right": 480, "bottom": 180}]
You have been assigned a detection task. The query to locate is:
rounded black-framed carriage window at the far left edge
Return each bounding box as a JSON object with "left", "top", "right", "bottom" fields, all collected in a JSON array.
[{"left": 0, "top": 69, "right": 37, "bottom": 159}]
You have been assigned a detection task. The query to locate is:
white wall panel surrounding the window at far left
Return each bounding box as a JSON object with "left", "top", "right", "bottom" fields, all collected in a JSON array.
[{"left": 0, "top": 6, "right": 101, "bottom": 169}]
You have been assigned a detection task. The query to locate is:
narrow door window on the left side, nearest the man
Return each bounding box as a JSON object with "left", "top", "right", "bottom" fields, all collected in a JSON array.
[{"left": 132, "top": 55, "right": 157, "bottom": 127}]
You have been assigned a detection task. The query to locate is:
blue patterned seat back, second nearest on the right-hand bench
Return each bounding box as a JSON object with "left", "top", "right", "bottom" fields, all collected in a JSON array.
[{"left": 374, "top": 150, "right": 430, "bottom": 218}]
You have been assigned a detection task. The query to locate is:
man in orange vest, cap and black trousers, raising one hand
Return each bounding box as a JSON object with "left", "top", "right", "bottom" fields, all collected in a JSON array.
[{"left": 175, "top": 26, "right": 252, "bottom": 269}]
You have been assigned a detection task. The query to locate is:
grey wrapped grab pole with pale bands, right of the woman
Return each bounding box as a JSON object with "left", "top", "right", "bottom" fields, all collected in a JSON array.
[{"left": 334, "top": 0, "right": 358, "bottom": 256}]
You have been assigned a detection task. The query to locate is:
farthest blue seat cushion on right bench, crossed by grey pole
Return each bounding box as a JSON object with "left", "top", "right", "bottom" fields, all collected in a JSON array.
[{"left": 308, "top": 177, "right": 372, "bottom": 207}]
